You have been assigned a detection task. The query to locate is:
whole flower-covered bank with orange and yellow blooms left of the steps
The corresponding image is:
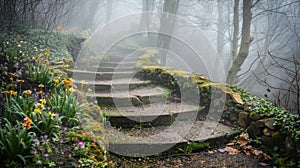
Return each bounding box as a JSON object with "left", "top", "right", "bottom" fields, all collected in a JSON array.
[{"left": 0, "top": 26, "right": 110, "bottom": 167}]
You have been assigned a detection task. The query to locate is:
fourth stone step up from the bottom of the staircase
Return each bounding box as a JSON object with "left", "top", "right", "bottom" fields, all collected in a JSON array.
[{"left": 74, "top": 78, "right": 151, "bottom": 93}]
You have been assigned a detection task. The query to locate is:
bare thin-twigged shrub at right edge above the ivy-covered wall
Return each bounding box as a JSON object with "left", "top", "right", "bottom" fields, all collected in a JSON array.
[{"left": 255, "top": 52, "right": 300, "bottom": 114}]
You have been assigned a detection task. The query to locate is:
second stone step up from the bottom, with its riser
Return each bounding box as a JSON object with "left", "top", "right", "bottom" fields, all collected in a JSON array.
[{"left": 105, "top": 102, "right": 202, "bottom": 128}]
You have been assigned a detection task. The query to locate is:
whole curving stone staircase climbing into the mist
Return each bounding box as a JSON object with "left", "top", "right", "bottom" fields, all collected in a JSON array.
[{"left": 69, "top": 46, "right": 238, "bottom": 157}]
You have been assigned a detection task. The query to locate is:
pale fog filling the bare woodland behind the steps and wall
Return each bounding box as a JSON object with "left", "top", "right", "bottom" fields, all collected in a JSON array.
[{"left": 1, "top": 0, "right": 300, "bottom": 113}]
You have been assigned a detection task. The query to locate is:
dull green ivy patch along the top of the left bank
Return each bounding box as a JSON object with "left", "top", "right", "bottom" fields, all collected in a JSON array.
[{"left": 0, "top": 26, "right": 84, "bottom": 61}]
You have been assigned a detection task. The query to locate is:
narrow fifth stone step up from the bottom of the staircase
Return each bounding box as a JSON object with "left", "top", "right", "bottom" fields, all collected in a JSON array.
[{"left": 68, "top": 70, "right": 134, "bottom": 81}]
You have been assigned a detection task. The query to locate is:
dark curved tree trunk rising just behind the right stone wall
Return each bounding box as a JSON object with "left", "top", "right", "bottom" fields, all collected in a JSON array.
[{"left": 226, "top": 0, "right": 252, "bottom": 84}]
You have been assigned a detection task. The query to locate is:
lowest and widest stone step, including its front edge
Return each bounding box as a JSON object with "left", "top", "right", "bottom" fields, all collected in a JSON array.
[{"left": 104, "top": 120, "right": 239, "bottom": 157}]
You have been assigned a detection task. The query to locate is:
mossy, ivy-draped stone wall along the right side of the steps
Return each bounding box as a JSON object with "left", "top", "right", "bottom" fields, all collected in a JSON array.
[{"left": 135, "top": 50, "right": 300, "bottom": 167}]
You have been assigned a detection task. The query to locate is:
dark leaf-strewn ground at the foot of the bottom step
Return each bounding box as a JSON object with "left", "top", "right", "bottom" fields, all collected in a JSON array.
[{"left": 111, "top": 146, "right": 272, "bottom": 168}]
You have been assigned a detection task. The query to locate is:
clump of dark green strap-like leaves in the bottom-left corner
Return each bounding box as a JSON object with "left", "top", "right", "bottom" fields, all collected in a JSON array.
[{"left": 0, "top": 119, "right": 35, "bottom": 163}]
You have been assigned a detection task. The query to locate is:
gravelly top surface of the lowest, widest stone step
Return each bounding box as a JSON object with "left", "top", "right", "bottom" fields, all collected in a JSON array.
[{"left": 105, "top": 120, "right": 237, "bottom": 144}]
